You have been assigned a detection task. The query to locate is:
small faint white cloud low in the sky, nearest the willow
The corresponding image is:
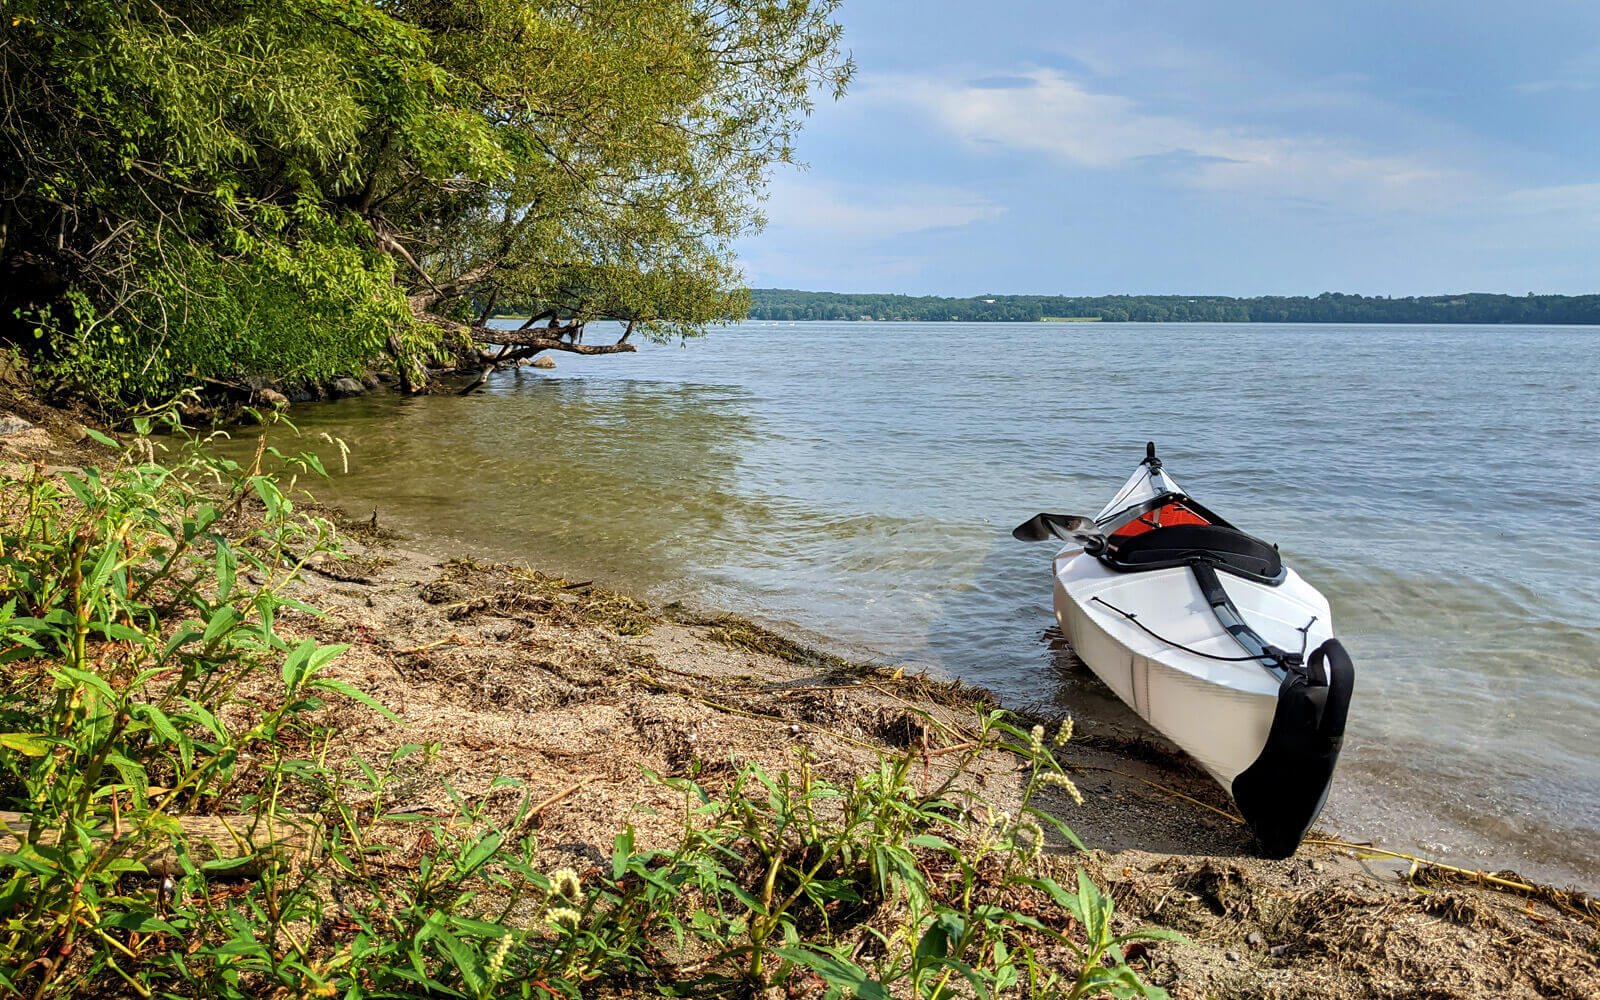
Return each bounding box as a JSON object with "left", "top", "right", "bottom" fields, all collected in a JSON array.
[{"left": 763, "top": 174, "right": 1005, "bottom": 240}]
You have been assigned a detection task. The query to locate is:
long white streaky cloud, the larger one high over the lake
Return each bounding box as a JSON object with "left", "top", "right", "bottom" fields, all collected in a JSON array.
[{"left": 858, "top": 69, "right": 1482, "bottom": 211}]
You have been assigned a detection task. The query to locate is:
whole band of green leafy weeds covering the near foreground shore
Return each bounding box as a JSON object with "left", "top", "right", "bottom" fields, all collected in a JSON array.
[{"left": 0, "top": 419, "right": 1171, "bottom": 1000}]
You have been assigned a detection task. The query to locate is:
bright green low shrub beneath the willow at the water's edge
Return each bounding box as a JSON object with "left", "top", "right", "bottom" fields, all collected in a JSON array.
[{"left": 29, "top": 208, "right": 419, "bottom": 413}]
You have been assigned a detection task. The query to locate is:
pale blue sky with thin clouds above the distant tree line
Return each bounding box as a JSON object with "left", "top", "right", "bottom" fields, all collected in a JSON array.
[{"left": 739, "top": 0, "right": 1600, "bottom": 296}]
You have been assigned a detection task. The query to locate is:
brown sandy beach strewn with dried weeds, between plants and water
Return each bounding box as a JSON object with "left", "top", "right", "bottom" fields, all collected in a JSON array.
[{"left": 252, "top": 523, "right": 1600, "bottom": 1000}]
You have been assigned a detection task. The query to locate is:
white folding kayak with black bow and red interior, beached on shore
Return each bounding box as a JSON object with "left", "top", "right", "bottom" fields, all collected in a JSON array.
[{"left": 1013, "top": 445, "right": 1355, "bottom": 858}]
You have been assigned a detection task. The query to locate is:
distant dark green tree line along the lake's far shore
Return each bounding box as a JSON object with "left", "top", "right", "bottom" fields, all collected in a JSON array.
[{"left": 750, "top": 288, "right": 1600, "bottom": 325}]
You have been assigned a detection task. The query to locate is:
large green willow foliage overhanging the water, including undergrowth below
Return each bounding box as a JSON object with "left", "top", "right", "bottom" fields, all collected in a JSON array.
[{"left": 0, "top": 0, "right": 850, "bottom": 402}]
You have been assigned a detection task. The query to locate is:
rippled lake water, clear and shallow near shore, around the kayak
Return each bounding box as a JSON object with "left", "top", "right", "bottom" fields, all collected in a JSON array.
[{"left": 236, "top": 323, "right": 1600, "bottom": 890}]
